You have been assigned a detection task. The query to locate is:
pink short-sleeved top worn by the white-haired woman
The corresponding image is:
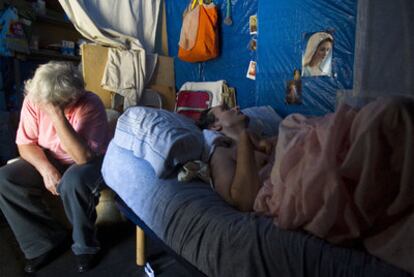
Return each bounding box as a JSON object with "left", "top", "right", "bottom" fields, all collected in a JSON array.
[{"left": 16, "top": 92, "right": 110, "bottom": 164}]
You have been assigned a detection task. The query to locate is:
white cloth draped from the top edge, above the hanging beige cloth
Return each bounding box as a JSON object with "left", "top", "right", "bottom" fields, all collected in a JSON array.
[{"left": 59, "top": 0, "right": 161, "bottom": 53}]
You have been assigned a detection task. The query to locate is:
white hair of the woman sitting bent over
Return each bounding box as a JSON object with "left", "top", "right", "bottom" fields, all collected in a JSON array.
[{"left": 25, "top": 61, "right": 85, "bottom": 106}]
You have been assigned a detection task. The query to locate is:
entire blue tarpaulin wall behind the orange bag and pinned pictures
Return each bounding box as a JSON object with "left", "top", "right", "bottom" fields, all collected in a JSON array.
[{"left": 166, "top": 0, "right": 357, "bottom": 115}]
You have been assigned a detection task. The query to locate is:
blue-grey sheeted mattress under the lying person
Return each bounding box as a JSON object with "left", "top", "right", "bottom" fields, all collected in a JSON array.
[{"left": 102, "top": 142, "right": 410, "bottom": 277}]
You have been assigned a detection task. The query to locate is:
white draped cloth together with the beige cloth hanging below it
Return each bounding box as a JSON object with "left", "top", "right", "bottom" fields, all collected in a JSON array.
[{"left": 59, "top": 0, "right": 161, "bottom": 108}]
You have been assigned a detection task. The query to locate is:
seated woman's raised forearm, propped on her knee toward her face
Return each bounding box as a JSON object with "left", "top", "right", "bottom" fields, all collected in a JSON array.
[{"left": 42, "top": 104, "right": 95, "bottom": 164}]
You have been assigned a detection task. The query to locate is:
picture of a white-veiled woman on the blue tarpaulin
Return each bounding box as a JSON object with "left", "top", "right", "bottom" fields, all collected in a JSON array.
[{"left": 302, "top": 31, "right": 334, "bottom": 77}]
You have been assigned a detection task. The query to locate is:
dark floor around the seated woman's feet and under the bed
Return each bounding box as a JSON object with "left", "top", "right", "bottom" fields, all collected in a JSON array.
[{"left": 0, "top": 210, "right": 200, "bottom": 277}]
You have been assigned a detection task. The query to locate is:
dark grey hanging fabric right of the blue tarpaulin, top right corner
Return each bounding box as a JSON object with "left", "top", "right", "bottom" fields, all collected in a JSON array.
[{"left": 354, "top": 0, "right": 414, "bottom": 97}]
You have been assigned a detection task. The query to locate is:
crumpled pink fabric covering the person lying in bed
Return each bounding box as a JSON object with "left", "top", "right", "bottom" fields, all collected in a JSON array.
[{"left": 254, "top": 99, "right": 414, "bottom": 273}]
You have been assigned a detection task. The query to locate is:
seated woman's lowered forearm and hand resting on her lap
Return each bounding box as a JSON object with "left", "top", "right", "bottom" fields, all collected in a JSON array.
[{"left": 17, "top": 144, "right": 62, "bottom": 195}]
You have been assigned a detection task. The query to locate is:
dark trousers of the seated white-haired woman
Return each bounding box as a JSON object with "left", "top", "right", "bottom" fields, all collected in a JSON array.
[{"left": 0, "top": 158, "right": 103, "bottom": 259}]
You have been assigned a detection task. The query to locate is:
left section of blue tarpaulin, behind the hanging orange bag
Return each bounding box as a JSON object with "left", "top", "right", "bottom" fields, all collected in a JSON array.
[{"left": 165, "top": 0, "right": 258, "bottom": 107}]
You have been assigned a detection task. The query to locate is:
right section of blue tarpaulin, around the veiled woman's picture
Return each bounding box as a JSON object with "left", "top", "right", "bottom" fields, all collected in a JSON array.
[{"left": 256, "top": 0, "right": 357, "bottom": 115}]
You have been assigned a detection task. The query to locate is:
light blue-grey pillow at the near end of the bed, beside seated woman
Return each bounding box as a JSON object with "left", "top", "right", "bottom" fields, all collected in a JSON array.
[{"left": 113, "top": 107, "right": 204, "bottom": 178}]
